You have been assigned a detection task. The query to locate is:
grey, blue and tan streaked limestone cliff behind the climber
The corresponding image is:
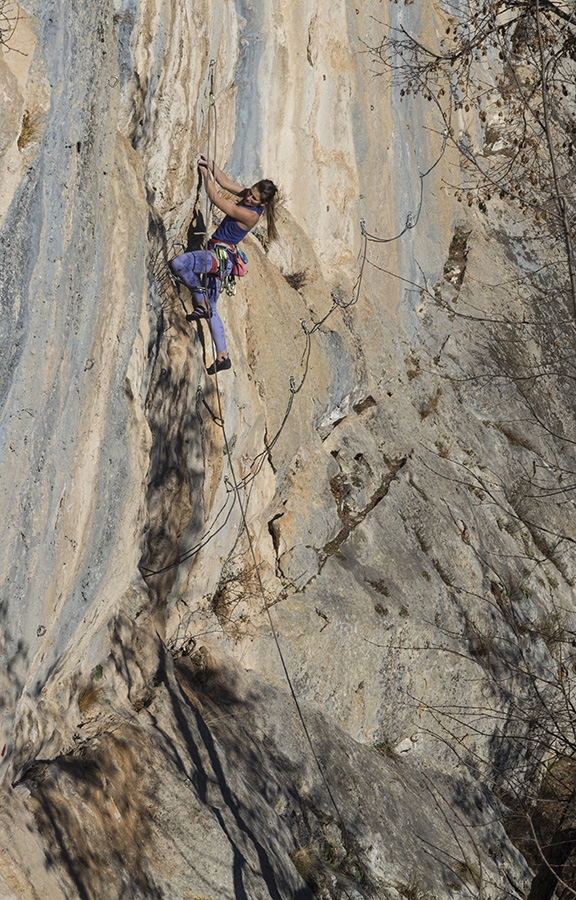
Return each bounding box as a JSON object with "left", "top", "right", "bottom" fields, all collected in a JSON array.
[{"left": 0, "top": 0, "right": 576, "bottom": 900}]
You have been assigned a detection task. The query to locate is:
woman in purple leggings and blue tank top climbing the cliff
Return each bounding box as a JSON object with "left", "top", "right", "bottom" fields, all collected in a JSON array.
[{"left": 170, "top": 155, "right": 278, "bottom": 375}]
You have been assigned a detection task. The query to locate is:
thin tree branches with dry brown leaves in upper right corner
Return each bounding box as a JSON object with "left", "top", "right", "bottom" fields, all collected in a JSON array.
[{"left": 370, "top": 0, "right": 576, "bottom": 315}]
